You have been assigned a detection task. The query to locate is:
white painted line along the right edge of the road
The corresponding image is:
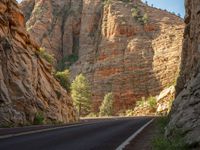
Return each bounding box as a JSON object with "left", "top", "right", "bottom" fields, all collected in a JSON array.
[{"left": 115, "top": 119, "right": 154, "bottom": 150}]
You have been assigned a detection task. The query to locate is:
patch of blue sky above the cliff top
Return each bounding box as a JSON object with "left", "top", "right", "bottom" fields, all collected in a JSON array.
[{"left": 142, "top": 0, "right": 185, "bottom": 17}]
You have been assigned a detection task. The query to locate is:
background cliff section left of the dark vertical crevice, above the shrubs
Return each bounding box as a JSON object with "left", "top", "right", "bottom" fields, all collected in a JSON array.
[{"left": 20, "top": 0, "right": 82, "bottom": 59}]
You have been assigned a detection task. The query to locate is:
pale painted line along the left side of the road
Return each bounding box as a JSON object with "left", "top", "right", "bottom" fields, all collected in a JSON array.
[{"left": 0, "top": 122, "right": 95, "bottom": 139}]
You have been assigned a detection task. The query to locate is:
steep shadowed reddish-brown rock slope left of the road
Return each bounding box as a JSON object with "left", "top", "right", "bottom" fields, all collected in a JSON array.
[{"left": 0, "top": 0, "right": 77, "bottom": 125}]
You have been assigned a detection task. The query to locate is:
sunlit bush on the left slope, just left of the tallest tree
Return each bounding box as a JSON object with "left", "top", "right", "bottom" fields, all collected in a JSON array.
[{"left": 55, "top": 69, "right": 70, "bottom": 92}]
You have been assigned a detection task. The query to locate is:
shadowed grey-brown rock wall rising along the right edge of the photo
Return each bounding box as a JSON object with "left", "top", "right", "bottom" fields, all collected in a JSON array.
[{"left": 167, "top": 0, "right": 200, "bottom": 149}]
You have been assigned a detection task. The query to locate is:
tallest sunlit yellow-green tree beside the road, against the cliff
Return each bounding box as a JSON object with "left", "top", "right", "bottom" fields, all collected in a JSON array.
[{"left": 71, "top": 74, "right": 91, "bottom": 116}]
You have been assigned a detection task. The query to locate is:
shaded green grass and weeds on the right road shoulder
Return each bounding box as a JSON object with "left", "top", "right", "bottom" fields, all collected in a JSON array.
[{"left": 152, "top": 117, "right": 189, "bottom": 150}]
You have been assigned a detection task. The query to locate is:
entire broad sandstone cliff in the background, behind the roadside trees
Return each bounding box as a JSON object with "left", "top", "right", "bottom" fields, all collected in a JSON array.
[{"left": 21, "top": 0, "right": 184, "bottom": 112}]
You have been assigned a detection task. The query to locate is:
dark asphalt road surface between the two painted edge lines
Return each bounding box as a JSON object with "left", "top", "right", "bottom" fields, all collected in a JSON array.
[{"left": 0, "top": 117, "right": 151, "bottom": 150}]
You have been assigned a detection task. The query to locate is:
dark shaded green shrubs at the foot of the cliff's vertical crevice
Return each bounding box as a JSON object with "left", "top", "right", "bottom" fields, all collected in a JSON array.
[{"left": 56, "top": 54, "right": 78, "bottom": 71}]
